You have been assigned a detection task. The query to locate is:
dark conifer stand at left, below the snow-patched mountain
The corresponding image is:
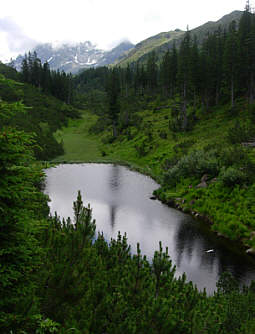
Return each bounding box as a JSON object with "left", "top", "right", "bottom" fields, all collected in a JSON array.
[{"left": 21, "top": 52, "right": 74, "bottom": 104}]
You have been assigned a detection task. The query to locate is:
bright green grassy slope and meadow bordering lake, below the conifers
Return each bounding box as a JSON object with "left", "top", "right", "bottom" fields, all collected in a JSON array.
[{"left": 52, "top": 94, "right": 255, "bottom": 247}]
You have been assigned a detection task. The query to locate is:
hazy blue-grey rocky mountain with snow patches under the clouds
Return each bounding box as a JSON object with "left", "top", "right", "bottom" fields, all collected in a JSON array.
[{"left": 12, "top": 41, "right": 134, "bottom": 73}]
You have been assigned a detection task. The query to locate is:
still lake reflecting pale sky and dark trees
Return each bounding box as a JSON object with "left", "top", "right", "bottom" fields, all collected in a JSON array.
[{"left": 45, "top": 164, "right": 255, "bottom": 293}]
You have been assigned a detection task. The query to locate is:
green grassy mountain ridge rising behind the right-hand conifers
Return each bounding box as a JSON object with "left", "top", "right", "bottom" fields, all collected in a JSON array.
[{"left": 115, "top": 11, "right": 243, "bottom": 66}]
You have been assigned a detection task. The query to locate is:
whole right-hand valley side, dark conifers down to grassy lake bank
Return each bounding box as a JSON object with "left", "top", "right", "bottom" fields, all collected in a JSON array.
[{"left": 74, "top": 2, "right": 255, "bottom": 252}]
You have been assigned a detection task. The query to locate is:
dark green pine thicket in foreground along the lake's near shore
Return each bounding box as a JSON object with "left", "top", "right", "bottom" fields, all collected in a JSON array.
[{"left": 34, "top": 194, "right": 255, "bottom": 334}]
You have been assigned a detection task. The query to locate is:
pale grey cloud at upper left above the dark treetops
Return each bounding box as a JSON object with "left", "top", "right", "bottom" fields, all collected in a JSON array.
[{"left": 0, "top": 17, "right": 38, "bottom": 54}]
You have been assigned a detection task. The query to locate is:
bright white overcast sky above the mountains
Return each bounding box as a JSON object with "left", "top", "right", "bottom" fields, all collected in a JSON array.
[{"left": 0, "top": 0, "right": 248, "bottom": 61}]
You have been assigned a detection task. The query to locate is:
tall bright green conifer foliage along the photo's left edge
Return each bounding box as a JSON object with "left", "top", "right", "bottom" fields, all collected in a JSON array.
[{"left": 0, "top": 102, "right": 48, "bottom": 333}]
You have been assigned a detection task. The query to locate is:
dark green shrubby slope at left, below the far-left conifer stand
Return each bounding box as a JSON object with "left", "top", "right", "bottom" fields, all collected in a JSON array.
[{"left": 0, "top": 68, "right": 79, "bottom": 160}]
